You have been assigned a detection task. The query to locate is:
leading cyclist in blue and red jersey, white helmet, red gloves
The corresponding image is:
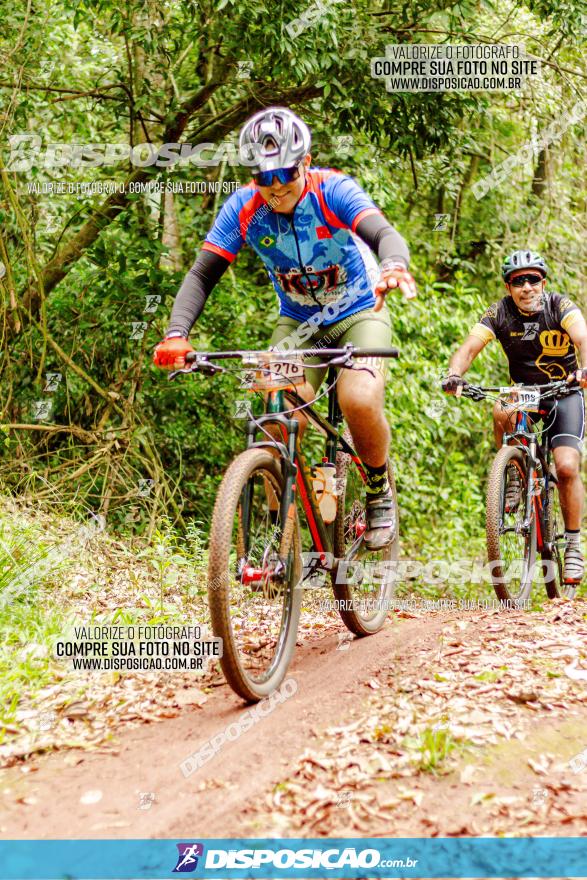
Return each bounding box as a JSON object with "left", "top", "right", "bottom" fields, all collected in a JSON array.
[{"left": 154, "top": 107, "right": 416, "bottom": 550}]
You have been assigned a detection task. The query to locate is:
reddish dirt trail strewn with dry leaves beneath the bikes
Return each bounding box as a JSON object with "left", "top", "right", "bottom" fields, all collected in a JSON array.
[{"left": 0, "top": 602, "right": 587, "bottom": 839}]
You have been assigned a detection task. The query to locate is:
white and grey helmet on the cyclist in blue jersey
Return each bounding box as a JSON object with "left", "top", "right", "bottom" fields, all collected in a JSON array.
[{"left": 239, "top": 107, "right": 312, "bottom": 172}]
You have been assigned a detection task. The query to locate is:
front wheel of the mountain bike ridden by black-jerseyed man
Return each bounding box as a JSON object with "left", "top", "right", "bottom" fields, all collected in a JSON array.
[{"left": 486, "top": 446, "right": 536, "bottom": 605}]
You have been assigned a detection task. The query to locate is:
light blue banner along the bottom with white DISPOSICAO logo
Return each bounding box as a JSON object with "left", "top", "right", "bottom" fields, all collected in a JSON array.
[{"left": 0, "top": 837, "right": 587, "bottom": 880}]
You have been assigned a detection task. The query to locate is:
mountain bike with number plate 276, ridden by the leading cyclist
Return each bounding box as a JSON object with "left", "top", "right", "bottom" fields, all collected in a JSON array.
[{"left": 170, "top": 345, "right": 399, "bottom": 701}]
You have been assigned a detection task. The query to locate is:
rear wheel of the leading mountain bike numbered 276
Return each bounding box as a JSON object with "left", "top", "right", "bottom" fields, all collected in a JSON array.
[{"left": 332, "top": 438, "right": 399, "bottom": 636}]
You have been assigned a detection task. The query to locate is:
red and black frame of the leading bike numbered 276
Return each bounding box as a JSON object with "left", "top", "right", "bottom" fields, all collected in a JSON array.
[{"left": 243, "top": 368, "right": 366, "bottom": 570}]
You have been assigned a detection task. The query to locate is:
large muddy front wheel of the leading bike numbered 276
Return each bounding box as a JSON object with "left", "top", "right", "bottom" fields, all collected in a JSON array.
[{"left": 208, "top": 449, "right": 302, "bottom": 701}]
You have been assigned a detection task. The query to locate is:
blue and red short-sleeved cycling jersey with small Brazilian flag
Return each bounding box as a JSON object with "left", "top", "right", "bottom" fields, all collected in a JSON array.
[{"left": 203, "top": 168, "right": 381, "bottom": 325}]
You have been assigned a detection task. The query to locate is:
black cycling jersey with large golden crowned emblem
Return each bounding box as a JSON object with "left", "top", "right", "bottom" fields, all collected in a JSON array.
[{"left": 471, "top": 293, "right": 581, "bottom": 385}]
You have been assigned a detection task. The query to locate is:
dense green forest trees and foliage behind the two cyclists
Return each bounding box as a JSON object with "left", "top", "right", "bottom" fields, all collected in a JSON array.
[{"left": 0, "top": 0, "right": 587, "bottom": 580}]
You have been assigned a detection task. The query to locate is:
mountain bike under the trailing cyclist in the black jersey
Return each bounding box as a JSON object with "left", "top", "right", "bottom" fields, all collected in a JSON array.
[{"left": 462, "top": 380, "right": 578, "bottom": 606}]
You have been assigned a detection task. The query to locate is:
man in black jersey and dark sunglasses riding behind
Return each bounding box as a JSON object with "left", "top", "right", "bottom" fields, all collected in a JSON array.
[{"left": 442, "top": 250, "right": 587, "bottom": 583}]
